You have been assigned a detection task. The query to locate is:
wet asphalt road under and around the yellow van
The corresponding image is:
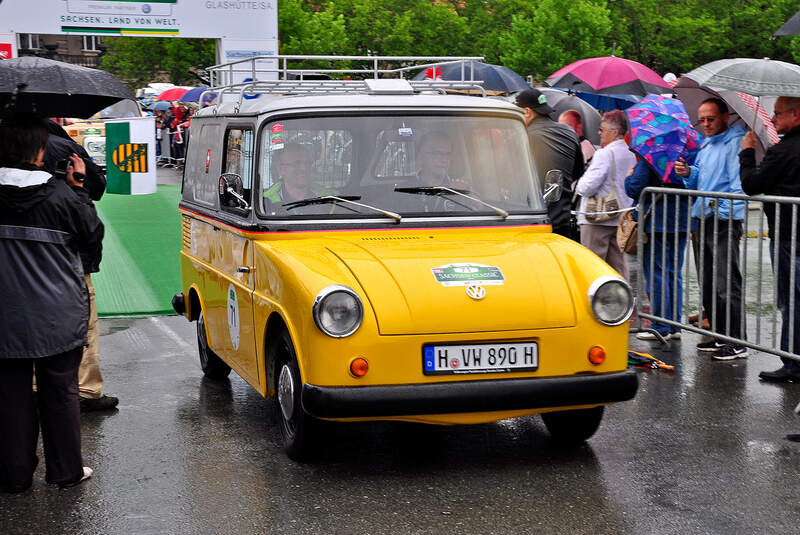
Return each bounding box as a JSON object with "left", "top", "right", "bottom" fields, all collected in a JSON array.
[{"left": 0, "top": 316, "right": 800, "bottom": 534}]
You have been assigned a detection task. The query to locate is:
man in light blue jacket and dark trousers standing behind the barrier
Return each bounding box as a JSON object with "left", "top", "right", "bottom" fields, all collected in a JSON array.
[{"left": 675, "top": 98, "right": 747, "bottom": 360}]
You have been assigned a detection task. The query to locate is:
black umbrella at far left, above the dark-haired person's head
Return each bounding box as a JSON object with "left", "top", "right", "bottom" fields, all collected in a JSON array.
[{"left": 0, "top": 57, "right": 136, "bottom": 119}]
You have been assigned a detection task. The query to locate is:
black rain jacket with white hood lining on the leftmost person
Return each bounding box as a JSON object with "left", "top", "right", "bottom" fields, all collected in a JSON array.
[{"left": 0, "top": 165, "right": 102, "bottom": 358}]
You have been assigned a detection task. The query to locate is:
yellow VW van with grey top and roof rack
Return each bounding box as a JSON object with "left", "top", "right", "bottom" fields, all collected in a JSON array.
[{"left": 173, "top": 57, "right": 638, "bottom": 460}]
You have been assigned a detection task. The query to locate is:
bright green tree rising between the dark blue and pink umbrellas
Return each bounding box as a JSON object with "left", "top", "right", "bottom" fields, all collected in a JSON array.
[{"left": 500, "top": 0, "right": 611, "bottom": 80}]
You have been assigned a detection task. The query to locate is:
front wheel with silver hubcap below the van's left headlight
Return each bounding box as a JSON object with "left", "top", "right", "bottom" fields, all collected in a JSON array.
[{"left": 270, "top": 329, "right": 318, "bottom": 462}]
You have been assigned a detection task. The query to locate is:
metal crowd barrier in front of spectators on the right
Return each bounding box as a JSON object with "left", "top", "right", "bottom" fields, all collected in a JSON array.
[{"left": 631, "top": 187, "right": 800, "bottom": 361}]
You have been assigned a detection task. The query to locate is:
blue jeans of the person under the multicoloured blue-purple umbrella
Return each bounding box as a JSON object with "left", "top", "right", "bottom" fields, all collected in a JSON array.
[{"left": 642, "top": 231, "right": 687, "bottom": 335}]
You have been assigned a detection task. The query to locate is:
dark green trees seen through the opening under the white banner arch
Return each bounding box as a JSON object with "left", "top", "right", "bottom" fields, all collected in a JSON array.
[{"left": 101, "top": 37, "right": 216, "bottom": 88}]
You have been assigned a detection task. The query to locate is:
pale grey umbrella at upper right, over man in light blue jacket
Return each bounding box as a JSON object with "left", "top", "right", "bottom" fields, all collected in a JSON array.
[{"left": 684, "top": 58, "right": 800, "bottom": 97}]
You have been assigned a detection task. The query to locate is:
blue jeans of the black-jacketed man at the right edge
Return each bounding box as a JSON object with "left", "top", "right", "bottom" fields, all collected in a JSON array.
[{"left": 769, "top": 240, "right": 800, "bottom": 373}]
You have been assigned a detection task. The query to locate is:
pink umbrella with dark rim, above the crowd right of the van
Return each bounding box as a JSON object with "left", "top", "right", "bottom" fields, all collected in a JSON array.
[{"left": 547, "top": 56, "right": 670, "bottom": 96}]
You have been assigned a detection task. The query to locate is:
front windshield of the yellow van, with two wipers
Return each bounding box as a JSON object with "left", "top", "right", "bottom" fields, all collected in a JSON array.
[{"left": 256, "top": 115, "right": 544, "bottom": 218}]
